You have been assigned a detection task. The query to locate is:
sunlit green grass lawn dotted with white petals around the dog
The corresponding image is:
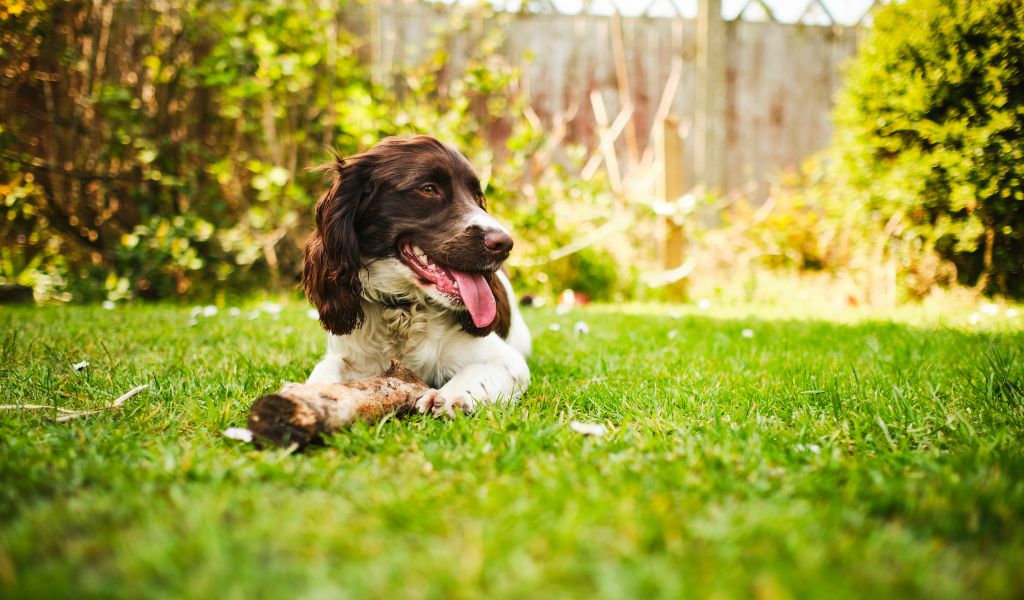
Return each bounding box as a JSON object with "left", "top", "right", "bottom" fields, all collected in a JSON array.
[{"left": 0, "top": 302, "right": 1024, "bottom": 598}]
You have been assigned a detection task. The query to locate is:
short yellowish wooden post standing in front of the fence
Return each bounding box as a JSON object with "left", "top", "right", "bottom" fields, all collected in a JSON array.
[{"left": 657, "top": 115, "right": 687, "bottom": 301}]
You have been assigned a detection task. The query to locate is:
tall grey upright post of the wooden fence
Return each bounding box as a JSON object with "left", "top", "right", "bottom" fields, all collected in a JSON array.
[{"left": 693, "top": 0, "right": 728, "bottom": 194}]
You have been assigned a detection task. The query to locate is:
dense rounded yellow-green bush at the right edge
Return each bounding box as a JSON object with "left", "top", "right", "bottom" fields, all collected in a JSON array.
[{"left": 831, "top": 0, "right": 1024, "bottom": 297}]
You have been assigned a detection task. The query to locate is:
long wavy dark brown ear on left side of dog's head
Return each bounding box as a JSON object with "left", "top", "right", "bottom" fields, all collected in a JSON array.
[{"left": 302, "top": 155, "right": 375, "bottom": 336}]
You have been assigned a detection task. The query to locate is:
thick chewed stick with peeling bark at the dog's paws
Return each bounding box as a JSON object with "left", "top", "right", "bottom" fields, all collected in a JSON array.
[{"left": 249, "top": 359, "right": 430, "bottom": 447}]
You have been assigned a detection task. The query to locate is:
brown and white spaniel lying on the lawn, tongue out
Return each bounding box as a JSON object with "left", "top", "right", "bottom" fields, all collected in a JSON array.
[{"left": 302, "top": 135, "right": 530, "bottom": 417}]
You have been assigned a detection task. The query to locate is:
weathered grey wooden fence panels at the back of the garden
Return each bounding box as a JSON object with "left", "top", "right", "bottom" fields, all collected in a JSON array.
[{"left": 370, "top": 0, "right": 857, "bottom": 198}]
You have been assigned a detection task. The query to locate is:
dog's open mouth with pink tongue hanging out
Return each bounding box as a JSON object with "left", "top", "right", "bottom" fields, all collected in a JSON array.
[{"left": 398, "top": 242, "right": 498, "bottom": 328}]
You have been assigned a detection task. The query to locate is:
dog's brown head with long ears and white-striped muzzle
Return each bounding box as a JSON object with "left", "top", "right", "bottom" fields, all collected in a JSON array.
[{"left": 302, "top": 135, "right": 512, "bottom": 336}]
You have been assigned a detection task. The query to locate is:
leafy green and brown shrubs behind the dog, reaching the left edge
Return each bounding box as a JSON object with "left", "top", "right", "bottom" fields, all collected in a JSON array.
[{"left": 0, "top": 0, "right": 598, "bottom": 299}]
